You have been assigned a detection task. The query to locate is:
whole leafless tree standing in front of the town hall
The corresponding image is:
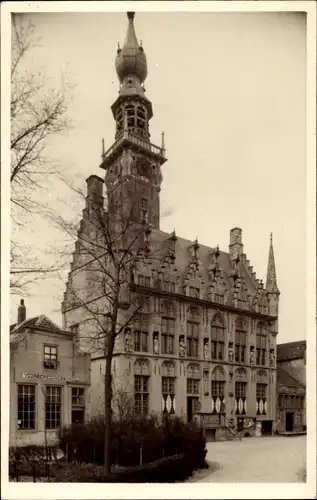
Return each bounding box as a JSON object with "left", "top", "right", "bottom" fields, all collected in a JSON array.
[{"left": 55, "top": 172, "right": 174, "bottom": 473}]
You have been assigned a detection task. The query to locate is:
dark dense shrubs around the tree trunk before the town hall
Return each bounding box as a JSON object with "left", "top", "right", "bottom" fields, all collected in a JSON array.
[{"left": 59, "top": 415, "right": 206, "bottom": 468}]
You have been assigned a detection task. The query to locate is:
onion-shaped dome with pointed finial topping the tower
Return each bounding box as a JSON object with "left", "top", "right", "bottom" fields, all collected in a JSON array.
[{"left": 115, "top": 12, "right": 147, "bottom": 83}]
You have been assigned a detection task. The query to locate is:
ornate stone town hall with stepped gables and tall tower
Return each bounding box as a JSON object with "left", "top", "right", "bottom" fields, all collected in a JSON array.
[{"left": 62, "top": 12, "right": 280, "bottom": 439}]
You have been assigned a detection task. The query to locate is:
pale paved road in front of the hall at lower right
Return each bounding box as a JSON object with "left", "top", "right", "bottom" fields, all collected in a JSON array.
[{"left": 193, "top": 436, "right": 306, "bottom": 483}]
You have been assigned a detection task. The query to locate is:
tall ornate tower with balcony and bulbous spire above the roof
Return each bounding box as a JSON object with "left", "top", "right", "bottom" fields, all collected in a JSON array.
[{"left": 100, "top": 12, "right": 166, "bottom": 229}]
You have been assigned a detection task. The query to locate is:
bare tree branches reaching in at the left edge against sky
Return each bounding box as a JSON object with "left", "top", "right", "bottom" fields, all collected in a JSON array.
[{"left": 10, "top": 14, "right": 71, "bottom": 293}]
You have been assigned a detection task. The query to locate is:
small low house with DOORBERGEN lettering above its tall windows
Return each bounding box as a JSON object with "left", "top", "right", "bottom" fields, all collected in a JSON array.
[{"left": 9, "top": 302, "right": 91, "bottom": 446}]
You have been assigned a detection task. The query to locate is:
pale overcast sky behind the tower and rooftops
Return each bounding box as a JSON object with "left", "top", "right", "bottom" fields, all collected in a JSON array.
[{"left": 11, "top": 12, "right": 306, "bottom": 342}]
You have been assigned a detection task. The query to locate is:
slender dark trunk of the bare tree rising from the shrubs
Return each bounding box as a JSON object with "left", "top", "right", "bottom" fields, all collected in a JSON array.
[{"left": 104, "top": 339, "right": 114, "bottom": 474}]
